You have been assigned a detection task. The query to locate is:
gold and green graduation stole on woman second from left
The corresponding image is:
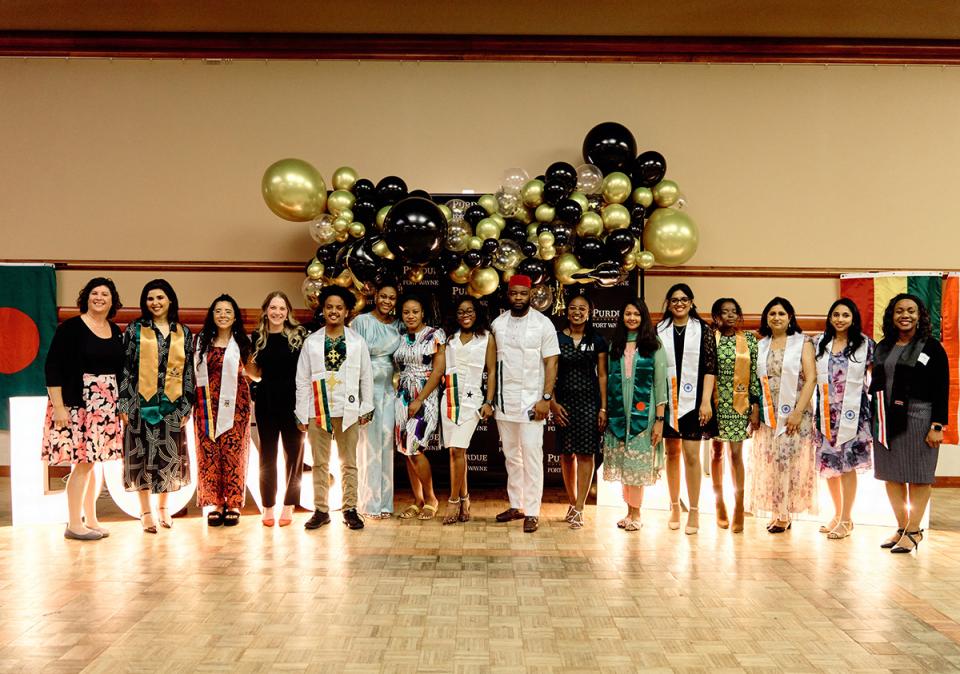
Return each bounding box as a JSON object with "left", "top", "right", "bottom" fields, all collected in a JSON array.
[{"left": 137, "top": 323, "right": 187, "bottom": 426}]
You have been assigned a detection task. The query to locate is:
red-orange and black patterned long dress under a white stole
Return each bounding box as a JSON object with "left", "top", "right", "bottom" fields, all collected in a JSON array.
[{"left": 193, "top": 346, "right": 250, "bottom": 508}]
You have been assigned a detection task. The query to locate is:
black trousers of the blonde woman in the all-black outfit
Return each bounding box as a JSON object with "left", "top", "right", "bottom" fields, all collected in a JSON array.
[{"left": 254, "top": 407, "right": 304, "bottom": 508}]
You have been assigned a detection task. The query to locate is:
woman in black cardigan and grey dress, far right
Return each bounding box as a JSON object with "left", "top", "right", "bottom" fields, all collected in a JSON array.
[{"left": 870, "top": 293, "right": 950, "bottom": 553}]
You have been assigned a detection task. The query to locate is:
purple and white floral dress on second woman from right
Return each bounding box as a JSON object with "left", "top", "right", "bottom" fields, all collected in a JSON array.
[{"left": 817, "top": 337, "right": 874, "bottom": 478}]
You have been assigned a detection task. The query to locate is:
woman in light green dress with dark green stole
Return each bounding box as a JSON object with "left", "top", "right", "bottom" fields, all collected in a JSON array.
[{"left": 603, "top": 299, "right": 667, "bottom": 531}]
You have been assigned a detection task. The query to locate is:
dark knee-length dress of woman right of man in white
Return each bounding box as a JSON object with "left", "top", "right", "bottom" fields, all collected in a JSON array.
[{"left": 554, "top": 332, "right": 607, "bottom": 454}]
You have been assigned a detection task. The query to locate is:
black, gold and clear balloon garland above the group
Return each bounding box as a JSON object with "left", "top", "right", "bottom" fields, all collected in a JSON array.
[{"left": 262, "top": 122, "right": 698, "bottom": 311}]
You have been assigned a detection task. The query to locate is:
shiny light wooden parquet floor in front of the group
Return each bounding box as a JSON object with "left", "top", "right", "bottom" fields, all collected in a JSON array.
[{"left": 0, "top": 490, "right": 960, "bottom": 674}]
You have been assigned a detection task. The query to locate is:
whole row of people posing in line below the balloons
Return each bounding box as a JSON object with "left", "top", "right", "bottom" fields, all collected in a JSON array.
[{"left": 43, "top": 274, "right": 949, "bottom": 552}]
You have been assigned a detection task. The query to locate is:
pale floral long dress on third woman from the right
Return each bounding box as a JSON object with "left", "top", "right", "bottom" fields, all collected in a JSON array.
[{"left": 747, "top": 337, "right": 819, "bottom": 516}]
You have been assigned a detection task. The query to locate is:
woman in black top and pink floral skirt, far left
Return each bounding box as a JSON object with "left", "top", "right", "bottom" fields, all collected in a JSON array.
[{"left": 42, "top": 277, "right": 123, "bottom": 541}]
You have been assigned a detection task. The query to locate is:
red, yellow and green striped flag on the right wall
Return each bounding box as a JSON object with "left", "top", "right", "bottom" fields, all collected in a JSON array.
[{"left": 840, "top": 271, "right": 943, "bottom": 342}]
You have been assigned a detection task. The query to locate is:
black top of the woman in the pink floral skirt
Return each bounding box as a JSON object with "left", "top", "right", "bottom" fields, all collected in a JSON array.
[{"left": 45, "top": 316, "right": 123, "bottom": 407}]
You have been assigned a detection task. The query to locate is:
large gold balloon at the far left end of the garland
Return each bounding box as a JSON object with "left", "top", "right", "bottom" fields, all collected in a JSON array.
[{"left": 260, "top": 159, "right": 327, "bottom": 222}]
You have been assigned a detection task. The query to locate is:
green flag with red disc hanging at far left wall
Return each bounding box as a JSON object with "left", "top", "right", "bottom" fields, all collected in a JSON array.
[{"left": 0, "top": 264, "right": 57, "bottom": 430}]
